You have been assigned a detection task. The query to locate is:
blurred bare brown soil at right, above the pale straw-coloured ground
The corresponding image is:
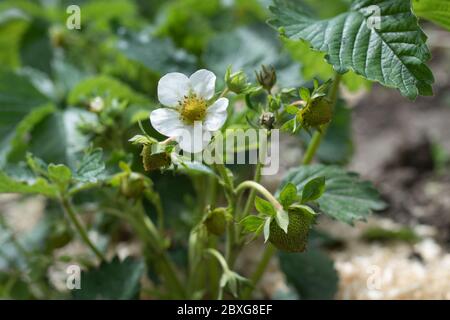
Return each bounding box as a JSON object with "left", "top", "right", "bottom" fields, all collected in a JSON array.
[{"left": 350, "top": 53, "right": 450, "bottom": 246}]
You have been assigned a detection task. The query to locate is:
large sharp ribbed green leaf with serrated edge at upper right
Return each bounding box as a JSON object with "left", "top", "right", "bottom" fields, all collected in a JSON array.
[{"left": 270, "top": 0, "right": 434, "bottom": 99}]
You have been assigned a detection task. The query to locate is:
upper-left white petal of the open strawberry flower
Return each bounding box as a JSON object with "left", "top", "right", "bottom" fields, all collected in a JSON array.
[{"left": 158, "top": 72, "right": 190, "bottom": 107}]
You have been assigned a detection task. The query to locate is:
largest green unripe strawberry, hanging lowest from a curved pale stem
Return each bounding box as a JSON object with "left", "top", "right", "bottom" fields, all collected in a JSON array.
[{"left": 269, "top": 209, "right": 314, "bottom": 252}]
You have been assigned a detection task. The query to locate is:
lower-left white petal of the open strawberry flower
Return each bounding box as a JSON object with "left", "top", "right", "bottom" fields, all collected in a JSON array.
[{"left": 150, "top": 108, "right": 184, "bottom": 137}]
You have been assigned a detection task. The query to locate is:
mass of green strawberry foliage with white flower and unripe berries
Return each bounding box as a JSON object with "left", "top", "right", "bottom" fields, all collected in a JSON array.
[{"left": 0, "top": 0, "right": 450, "bottom": 299}]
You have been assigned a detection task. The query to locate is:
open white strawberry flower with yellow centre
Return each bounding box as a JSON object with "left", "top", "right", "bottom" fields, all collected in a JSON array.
[{"left": 150, "top": 69, "right": 228, "bottom": 153}]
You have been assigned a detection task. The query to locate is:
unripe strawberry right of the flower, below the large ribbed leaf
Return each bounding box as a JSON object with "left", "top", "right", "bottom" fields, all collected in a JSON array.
[{"left": 300, "top": 97, "right": 333, "bottom": 128}]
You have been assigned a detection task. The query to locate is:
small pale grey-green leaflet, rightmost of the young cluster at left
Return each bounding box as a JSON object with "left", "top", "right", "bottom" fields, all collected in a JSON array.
[{"left": 75, "top": 148, "right": 105, "bottom": 183}]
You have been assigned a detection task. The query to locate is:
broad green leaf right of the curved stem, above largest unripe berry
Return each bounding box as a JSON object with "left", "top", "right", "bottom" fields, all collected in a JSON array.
[{"left": 279, "top": 164, "right": 386, "bottom": 224}]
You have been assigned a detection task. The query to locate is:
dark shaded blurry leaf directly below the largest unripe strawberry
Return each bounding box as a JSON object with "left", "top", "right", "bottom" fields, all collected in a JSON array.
[{"left": 278, "top": 248, "right": 338, "bottom": 300}]
